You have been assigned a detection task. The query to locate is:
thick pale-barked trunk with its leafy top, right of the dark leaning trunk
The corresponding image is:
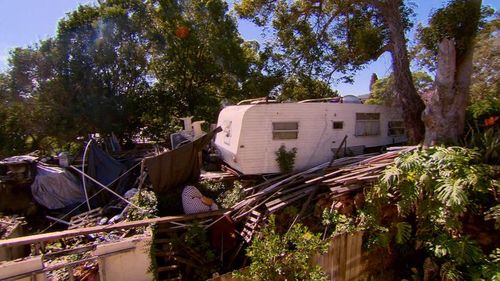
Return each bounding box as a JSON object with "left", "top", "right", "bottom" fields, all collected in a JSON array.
[{"left": 420, "top": 0, "right": 481, "bottom": 145}]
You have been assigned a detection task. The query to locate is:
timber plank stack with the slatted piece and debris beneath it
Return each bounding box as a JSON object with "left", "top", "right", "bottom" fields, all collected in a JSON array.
[{"left": 230, "top": 146, "right": 417, "bottom": 243}]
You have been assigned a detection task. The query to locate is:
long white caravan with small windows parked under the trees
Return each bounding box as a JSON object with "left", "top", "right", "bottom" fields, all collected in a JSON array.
[{"left": 215, "top": 97, "right": 406, "bottom": 175}]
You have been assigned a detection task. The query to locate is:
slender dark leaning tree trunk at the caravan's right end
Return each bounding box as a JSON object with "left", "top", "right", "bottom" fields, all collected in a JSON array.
[{"left": 378, "top": 0, "right": 425, "bottom": 143}]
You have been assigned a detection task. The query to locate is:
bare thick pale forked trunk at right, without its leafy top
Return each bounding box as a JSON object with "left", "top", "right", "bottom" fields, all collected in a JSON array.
[{"left": 423, "top": 39, "right": 472, "bottom": 146}]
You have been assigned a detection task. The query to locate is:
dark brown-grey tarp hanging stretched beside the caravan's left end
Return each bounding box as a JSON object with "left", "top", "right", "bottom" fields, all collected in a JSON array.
[{"left": 143, "top": 127, "right": 221, "bottom": 193}]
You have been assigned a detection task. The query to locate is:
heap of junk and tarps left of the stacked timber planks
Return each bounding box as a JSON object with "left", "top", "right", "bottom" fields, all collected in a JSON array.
[{"left": 0, "top": 123, "right": 234, "bottom": 280}]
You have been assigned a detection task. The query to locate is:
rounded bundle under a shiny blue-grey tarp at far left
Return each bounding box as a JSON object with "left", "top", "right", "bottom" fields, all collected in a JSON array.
[{"left": 31, "top": 163, "right": 85, "bottom": 209}]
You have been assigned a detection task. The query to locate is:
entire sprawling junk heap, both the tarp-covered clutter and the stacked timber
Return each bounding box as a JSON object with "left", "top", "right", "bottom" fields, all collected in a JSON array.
[{"left": 0, "top": 118, "right": 416, "bottom": 280}]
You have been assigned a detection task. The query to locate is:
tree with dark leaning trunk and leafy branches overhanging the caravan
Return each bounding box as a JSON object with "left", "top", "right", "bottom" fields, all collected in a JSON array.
[{"left": 236, "top": 0, "right": 425, "bottom": 143}]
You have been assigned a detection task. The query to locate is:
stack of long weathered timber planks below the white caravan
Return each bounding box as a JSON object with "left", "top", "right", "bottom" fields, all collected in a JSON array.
[{"left": 231, "top": 146, "right": 417, "bottom": 222}]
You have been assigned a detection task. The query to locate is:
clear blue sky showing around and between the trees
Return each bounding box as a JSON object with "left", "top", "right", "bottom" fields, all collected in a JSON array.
[{"left": 0, "top": 0, "right": 500, "bottom": 95}]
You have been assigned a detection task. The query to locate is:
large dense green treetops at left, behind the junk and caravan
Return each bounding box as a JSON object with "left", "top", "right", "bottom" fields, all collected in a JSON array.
[{"left": 0, "top": 0, "right": 258, "bottom": 154}]
